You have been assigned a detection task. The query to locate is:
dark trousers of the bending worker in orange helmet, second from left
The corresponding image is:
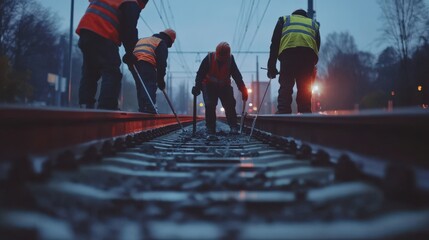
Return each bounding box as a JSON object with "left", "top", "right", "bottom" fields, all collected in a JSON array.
[{"left": 131, "top": 61, "right": 157, "bottom": 113}]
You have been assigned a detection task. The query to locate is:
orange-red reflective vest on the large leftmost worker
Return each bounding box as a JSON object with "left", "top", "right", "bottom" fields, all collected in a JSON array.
[{"left": 76, "top": 0, "right": 138, "bottom": 46}]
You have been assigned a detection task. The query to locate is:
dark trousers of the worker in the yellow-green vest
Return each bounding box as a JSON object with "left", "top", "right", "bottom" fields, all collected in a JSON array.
[{"left": 277, "top": 48, "right": 317, "bottom": 114}]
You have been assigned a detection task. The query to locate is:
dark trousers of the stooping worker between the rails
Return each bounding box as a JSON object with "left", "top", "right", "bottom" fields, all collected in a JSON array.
[{"left": 202, "top": 84, "right": 237, "bottom": 131}]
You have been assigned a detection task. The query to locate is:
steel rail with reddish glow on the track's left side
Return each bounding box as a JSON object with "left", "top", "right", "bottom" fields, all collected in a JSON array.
[{"left": 0, "top": 106, "right": 197, "bottom": 160}]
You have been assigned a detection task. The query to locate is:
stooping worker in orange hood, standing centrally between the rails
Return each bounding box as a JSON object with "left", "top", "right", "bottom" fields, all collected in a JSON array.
[{"left": 192, "top": 42, "right": 248, "bottom": 135}]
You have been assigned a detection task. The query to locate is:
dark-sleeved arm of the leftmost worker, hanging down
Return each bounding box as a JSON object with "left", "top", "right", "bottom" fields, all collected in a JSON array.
[{"left": 119, "top": 2, "right": 141, "bottom": 54}]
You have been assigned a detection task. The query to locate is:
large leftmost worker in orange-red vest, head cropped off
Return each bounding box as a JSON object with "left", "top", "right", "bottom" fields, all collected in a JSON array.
[{"left": 76, "top": 0, "right": 148, "bottom": 110}]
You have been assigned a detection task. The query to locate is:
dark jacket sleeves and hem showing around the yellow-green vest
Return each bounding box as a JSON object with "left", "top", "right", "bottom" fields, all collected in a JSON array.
[{"left": 268, "top": 14, "right": 320, "bottom": 69}]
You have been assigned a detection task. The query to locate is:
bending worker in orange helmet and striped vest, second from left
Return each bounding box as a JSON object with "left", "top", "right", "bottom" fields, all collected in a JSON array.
[{"left": 125, "top": 29, "right": 176, "bottom": 114}]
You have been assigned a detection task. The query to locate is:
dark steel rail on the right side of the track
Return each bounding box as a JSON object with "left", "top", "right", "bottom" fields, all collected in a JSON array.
[{"left": 242, "top": 109, "right": 429, "bottom": 167}]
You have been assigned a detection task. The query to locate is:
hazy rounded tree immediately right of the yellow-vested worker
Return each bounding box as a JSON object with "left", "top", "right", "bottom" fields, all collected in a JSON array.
[{"left": 320, "top": 33, "right": 375, "bottom": 109}]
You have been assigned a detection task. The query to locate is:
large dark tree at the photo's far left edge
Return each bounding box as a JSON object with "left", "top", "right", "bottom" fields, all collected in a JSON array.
[{"left": 0, "top": 0, "right": 64, "bottom": 101}]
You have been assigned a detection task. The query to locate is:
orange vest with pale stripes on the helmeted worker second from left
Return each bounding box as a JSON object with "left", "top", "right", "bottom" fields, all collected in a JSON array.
[{"left": 133, "top": 37, "right": 162, "bottom": 68}]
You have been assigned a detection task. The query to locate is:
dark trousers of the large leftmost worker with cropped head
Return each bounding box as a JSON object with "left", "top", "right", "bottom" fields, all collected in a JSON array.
[{"left": 79, "top": 30, "right": 122, "bottom": 110}]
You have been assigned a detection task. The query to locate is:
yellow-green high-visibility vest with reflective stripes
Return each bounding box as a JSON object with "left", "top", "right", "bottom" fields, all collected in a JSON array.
[{"left": 278, "top": 15, "right": 319, "bottom": 55}]
